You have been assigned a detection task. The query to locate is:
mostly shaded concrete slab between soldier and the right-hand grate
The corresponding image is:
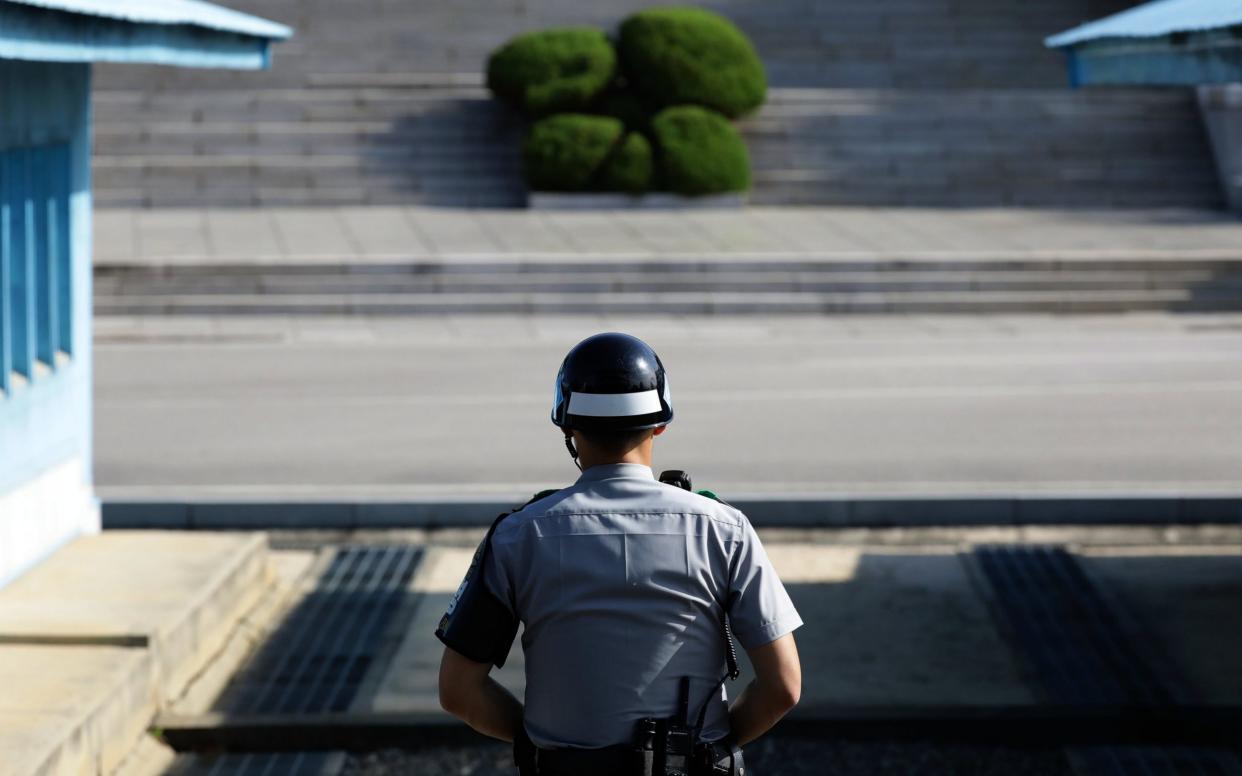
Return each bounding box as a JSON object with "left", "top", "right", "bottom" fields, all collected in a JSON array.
[{"left": 770, "top": 544, "right": 1036, "bottom": 714}]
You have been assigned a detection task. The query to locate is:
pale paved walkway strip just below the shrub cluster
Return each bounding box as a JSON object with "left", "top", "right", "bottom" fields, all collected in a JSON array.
[{"left": 94, "top": 206, "right": 1242, "bottom": 264}]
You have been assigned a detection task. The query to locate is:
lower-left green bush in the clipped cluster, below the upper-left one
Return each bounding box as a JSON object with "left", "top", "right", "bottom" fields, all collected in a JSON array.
[{"left": 523, "top": 113, "right": 625, "bottom": 191}]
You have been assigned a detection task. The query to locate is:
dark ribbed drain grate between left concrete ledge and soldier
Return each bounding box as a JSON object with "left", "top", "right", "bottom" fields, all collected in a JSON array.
[{"left": 217, "top": 545, "right": 422, "bottom": 715}]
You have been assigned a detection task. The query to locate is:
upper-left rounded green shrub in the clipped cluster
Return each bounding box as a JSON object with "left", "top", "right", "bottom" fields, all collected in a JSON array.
[{"left": 487, "top": 27, "right": 617, "bottom": 117}]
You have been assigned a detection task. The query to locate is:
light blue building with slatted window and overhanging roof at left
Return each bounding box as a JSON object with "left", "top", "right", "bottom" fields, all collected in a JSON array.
[{"left": 0, "top": 0, "right": 291, "bottom": 585}]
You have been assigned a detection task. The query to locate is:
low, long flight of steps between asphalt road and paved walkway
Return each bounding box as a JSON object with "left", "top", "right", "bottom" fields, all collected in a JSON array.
[{"left": 96, "top": 257, "right": 1242, "bottom": 315}]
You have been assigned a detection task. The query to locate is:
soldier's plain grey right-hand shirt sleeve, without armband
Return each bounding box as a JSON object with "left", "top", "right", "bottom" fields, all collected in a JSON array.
[{"left": 729, "top": 520, "right": 802, "bottom": 649}]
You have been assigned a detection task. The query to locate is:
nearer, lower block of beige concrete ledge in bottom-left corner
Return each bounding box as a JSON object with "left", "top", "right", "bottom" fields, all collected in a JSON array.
[{"left": 0, "top": 644, "right": 159, "bottom": 776}]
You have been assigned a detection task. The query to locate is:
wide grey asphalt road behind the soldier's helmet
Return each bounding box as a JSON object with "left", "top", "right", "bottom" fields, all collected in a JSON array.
[{"left": 96, "top": 315, "right": 1242, "bottom": 499}]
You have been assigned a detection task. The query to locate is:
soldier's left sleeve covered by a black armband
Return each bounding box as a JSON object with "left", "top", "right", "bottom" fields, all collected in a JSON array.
[{"left": 436, "top": 533, "right": 518, "bottom": 668}]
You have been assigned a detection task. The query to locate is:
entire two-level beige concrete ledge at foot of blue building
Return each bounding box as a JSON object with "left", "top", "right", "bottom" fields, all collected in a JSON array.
[{"left": 0, "top": 531, "right": 270, "bottom": 776}]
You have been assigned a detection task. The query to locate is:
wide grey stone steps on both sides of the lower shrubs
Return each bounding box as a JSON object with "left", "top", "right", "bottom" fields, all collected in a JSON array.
[{"left": 94, "top": 85, "right": 1220, "bottom": 207}]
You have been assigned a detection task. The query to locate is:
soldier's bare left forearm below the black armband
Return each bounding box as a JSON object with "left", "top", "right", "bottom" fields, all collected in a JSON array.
[{"left": 440, "top": 647, "right": 522, "bottom": 741}]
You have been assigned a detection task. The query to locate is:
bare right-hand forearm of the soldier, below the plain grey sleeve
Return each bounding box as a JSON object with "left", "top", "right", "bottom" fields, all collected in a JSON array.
[{"left": 729, "top": 633, "right": 802, "bottom": 745}]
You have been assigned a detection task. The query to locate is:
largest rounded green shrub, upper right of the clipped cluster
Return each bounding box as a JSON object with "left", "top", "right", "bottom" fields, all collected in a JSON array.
[{"left": 617, "top": 7, "right": 768, "bottom": 118}]
